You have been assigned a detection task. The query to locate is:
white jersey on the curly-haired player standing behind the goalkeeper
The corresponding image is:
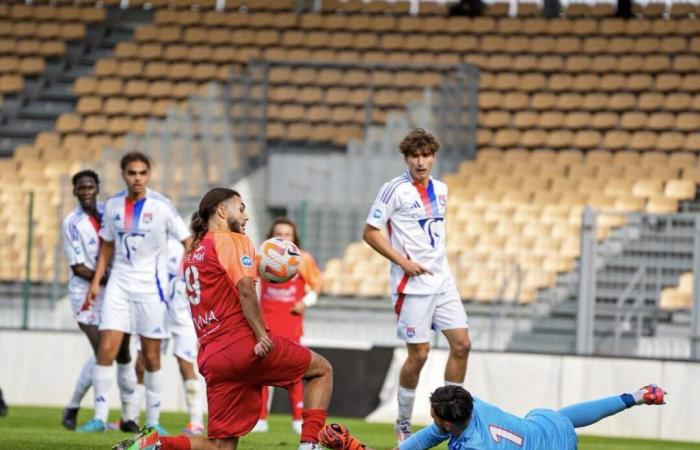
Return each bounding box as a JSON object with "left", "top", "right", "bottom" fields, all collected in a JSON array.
[{"left": 367, "top": 171, "right": 454, "bottom": 295}]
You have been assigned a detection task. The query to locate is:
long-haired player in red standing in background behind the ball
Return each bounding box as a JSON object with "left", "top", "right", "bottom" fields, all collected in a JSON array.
[{"left": 253, "top": 218, "right": 323, "bottom": 434}]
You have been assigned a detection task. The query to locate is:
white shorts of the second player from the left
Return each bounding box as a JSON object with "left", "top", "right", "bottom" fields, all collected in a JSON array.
[{"left": 100, "top": 278, "right": 168, "bottom": 339}]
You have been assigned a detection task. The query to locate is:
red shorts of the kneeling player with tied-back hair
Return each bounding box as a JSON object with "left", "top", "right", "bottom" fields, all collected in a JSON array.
[{"left": 199, "top": 333, "right": 311, "bottom": 439}]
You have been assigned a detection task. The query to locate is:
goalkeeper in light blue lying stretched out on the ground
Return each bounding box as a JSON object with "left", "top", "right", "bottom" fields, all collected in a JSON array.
[{"left": 321, "top": 384, "right": 666, "bottom": 450}]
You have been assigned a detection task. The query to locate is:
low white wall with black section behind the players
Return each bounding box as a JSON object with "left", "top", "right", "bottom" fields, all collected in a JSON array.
[{"left": 0, "top": 330, "right": 700, "bottom": 441}]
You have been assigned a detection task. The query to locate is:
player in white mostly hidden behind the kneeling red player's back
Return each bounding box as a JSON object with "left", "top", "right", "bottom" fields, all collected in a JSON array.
[{"left": 136, "top": 237, "right": 204, "bottom": 436}]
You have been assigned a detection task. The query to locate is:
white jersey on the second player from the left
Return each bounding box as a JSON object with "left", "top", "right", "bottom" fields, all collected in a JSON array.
[{"left": 100, "top": 189, "right": 190, "bottom": 299}]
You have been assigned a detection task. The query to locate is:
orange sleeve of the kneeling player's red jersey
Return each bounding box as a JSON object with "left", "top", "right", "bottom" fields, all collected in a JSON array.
[{"left": 214, "top": 233, "right": 257, "bottom": 286}]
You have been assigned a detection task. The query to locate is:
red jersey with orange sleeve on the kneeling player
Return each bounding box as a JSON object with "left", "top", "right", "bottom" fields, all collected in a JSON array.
[{"left": 183, "top": 231, "right": 257, "bottom": 362}]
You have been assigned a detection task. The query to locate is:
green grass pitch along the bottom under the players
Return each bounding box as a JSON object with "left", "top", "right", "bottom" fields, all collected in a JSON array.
[{"left": 0, "top": 405, "right": 700, "bottom": 450}]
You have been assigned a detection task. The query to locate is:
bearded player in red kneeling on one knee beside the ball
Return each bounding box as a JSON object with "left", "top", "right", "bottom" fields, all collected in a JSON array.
[{"left": 113, "top": 188, "right": 333, "bottom": 450}]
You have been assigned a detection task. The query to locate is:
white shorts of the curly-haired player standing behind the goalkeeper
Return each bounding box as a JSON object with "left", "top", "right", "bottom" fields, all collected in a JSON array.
[{"left": 391, "top": 289, "right": 469, "bottom": 344}]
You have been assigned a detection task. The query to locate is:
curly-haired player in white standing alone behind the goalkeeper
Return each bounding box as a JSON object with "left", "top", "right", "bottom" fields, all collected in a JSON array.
[{"left": 363, "top": 128, "right": 471, "bottom": 442}]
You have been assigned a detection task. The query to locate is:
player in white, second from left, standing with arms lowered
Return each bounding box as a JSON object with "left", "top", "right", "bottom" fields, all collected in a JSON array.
[{"left": 78, "top": 152, "right": 190, "bottom": 432}]
